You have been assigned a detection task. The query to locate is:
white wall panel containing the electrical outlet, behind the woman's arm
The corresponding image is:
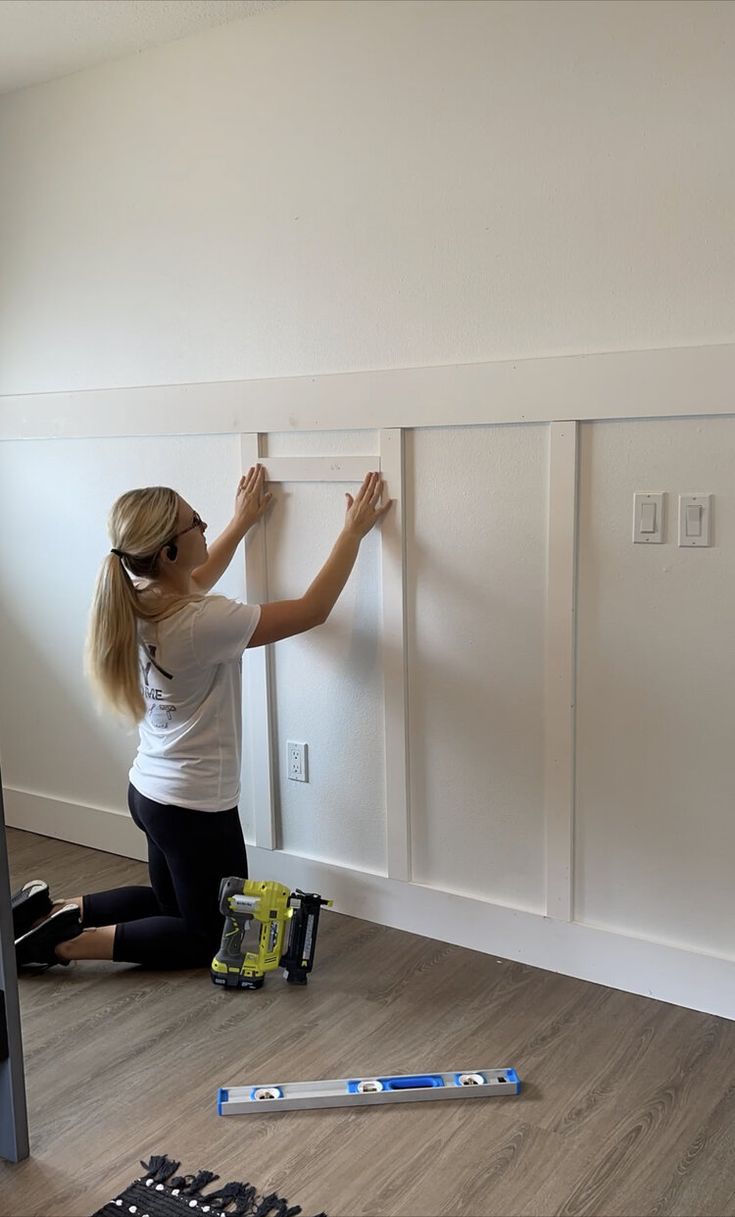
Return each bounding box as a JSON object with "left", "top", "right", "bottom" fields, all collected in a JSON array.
[{"left": 264, "top": 431, "right": 386, "bottom": 874}]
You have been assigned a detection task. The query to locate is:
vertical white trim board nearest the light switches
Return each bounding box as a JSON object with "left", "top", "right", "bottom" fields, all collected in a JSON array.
[{"left": 544, "top": 422, "right": 578, "bottom": 921}]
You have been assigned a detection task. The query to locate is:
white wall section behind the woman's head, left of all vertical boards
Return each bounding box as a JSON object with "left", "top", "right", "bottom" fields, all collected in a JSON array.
[{"left": 0, "top": 436, "right": 248, "bottom": 808}]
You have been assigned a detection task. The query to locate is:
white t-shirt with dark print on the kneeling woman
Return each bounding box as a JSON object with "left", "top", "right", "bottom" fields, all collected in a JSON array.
[{"left": 130, "top": 596, "right": 260, "bottom": 812}]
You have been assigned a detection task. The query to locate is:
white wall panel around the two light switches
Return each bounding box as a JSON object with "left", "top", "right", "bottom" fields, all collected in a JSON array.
[{"left": 577, "top": 417, "right": 735, "bottom": 957}]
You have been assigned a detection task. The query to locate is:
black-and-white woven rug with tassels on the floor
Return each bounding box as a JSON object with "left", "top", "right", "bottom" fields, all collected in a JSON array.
[{"left": 92, "top": 1155, "right": 326, "bottom": 1217}]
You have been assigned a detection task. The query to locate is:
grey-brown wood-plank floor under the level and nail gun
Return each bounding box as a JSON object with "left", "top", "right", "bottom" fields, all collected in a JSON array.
[{"left": 0, "top": 830, "right": 735, "bottom": 1217}]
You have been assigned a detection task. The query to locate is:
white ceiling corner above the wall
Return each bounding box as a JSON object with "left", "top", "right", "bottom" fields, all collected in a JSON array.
[{"left": 0, "top": 0, "right": 287, "bottom": 94}]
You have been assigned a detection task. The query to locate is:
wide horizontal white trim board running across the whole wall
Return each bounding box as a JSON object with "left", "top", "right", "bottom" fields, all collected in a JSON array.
[{"left": 0, "top": 343, "right": 735, "bottom": 441}]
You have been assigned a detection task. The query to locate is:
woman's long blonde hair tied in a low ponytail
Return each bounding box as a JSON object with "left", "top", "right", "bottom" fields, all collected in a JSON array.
[{"left": 86, "top": 486, "right": 200, "bottom": 723}]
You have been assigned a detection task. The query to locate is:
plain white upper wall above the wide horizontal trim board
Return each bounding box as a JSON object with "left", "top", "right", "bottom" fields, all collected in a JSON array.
[{"left": 0, "top": 0, "right": 735, "bottom": 393}]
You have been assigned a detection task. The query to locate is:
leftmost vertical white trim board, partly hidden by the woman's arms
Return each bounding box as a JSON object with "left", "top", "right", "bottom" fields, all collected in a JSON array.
[{"left": 240, "top": 433, "right": 277, "bottom": 849}]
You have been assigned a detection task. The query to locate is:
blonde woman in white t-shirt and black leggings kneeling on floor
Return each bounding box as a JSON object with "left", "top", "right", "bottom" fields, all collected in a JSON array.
[{"left": 12, "top": 465, "right": 391, "bottom": 971}]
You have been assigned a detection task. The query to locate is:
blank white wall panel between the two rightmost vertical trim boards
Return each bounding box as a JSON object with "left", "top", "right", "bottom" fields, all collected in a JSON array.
[{"left": 406, "top": 426, "right": 548, "bottom": 910}]
